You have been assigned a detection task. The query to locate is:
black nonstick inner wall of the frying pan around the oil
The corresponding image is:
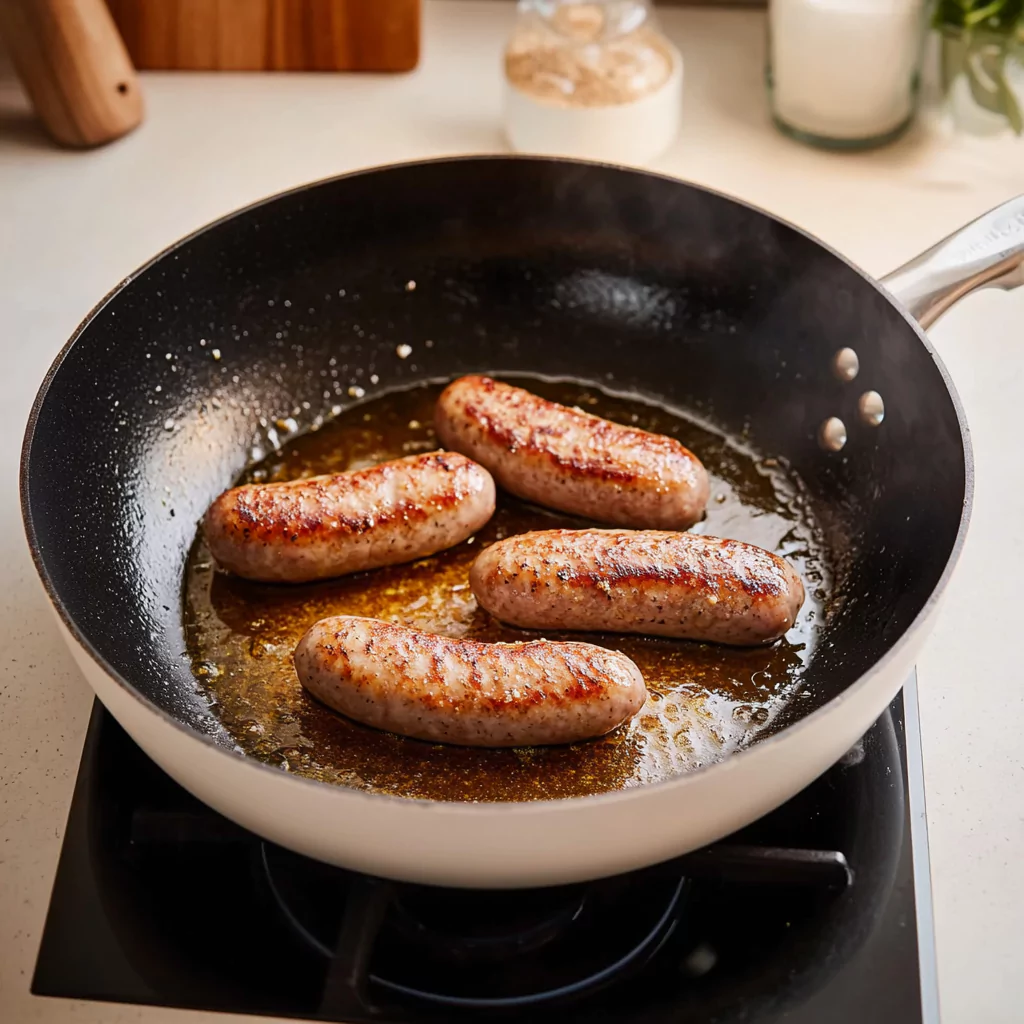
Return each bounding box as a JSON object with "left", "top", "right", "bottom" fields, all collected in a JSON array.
[{"left": 23, "top": 158, "right": 966, "bottom": 790}]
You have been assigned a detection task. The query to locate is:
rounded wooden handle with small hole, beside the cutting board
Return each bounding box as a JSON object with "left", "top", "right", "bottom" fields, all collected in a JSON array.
[{"left": 0, "top": 0, "right": 142, "bottom": 146}]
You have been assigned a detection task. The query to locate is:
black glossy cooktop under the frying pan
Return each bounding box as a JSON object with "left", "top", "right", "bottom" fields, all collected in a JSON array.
[{"left": 33, "top": 678, "right": 938, "bottom": 1024}]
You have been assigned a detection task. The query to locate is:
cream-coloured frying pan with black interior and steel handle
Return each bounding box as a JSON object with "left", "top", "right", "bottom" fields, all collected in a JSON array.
[{"left": 22, "top": 158, "right": 1024, "bottom": 887}]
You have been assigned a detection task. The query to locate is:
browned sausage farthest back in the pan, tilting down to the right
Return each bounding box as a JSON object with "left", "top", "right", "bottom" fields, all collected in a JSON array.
[{"left": 435, "top": 377, "right": 710, "bottom": 529}]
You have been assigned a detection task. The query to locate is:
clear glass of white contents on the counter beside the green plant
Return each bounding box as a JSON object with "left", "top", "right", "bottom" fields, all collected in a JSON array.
[{"left": 769, "top": 0, "right": 925, "bottom": 140}]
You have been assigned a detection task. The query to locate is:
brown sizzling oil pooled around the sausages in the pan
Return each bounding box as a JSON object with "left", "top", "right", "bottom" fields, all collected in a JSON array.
[{"left": 184, "top": 380, "right": 828, "bottom": 801}]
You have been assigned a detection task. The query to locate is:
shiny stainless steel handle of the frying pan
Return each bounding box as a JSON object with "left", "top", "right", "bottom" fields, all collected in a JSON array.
[{"left": 882, "top": 196, "right": 1024, "bottom": 330}]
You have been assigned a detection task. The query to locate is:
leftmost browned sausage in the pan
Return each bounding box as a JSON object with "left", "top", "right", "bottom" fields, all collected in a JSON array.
[{"left": 203, "top": 452, "right": 495, "bottom": 583}]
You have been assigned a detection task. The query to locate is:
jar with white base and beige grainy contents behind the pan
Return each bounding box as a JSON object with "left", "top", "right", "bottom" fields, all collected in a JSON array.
[{"left": 505, "top": 0, "right": 683, "bottom": 164}]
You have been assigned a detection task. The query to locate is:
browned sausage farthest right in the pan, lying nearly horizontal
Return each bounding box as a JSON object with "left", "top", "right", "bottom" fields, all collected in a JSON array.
[{"left": 469, "top": 529, "right": 804, "bottom": 646}]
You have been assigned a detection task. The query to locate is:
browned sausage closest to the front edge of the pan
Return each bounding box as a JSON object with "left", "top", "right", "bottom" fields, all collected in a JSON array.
[{"left": 295, "top": 615, "right": 647, "bottom": 746}]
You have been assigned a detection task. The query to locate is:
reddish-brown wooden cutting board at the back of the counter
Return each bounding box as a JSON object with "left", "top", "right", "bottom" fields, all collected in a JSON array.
[{"left": 104, "top": 0, "right": 420, "bottom": 71}]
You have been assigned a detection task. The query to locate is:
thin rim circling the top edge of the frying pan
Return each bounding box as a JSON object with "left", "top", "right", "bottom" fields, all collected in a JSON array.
[{"left": 18, "top": 154, "right": 975, "bottom": 817}]
